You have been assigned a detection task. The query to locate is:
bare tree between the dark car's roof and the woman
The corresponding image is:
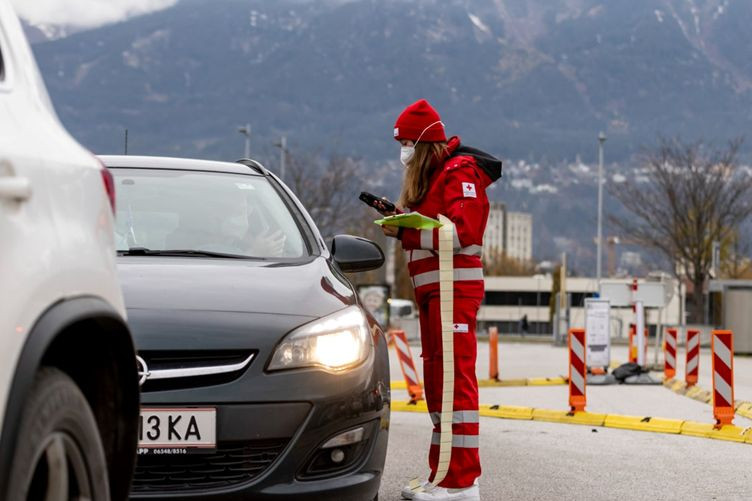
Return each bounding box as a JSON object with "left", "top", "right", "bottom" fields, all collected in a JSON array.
[{"left": 286, "top": 148, "right": 361, "bottom": 242}]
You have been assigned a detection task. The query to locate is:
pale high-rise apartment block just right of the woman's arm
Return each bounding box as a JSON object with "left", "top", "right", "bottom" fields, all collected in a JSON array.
[{"left": 483, "top": 202, "right": 533, "bottom": 261}]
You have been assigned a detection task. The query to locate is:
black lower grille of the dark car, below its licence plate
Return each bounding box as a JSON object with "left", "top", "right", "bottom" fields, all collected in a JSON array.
[{"left": 132, "top": 439, "right": 287, "bottom": 493}]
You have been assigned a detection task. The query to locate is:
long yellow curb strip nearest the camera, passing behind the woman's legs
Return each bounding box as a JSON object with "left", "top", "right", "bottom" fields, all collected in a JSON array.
[{"left": 392, "top": 400, "right": 752, "bottom": 444}]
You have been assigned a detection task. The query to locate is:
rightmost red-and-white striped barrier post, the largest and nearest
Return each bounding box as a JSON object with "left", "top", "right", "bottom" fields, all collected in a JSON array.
[{"left": 711, "top": 331, "right": 734, "bottom": 426}]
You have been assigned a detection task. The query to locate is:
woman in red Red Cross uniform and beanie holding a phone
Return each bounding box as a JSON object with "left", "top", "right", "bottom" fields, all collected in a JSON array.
[{"left": 384, "top": 99, "right": 501, "bottom": 500}]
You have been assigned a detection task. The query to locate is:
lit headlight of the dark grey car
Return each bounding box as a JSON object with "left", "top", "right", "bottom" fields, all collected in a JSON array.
[{"left": 268, "top": 306, "right": 371, "bottom": 371}]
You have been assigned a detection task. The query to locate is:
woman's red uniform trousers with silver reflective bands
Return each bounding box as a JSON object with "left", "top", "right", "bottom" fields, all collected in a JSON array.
[{"left": 419, "top": 293, "right": 481, "bottom": 489}]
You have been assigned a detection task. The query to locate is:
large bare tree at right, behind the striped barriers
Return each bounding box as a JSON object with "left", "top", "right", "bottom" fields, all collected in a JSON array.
[{"left": 610, "top": 139, "right": 752, "bottom": 322}]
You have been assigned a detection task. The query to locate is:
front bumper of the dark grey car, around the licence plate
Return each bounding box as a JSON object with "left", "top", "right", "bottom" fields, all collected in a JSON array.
[{"left": 131, "top": 338, "right": 390, "bottom": 501}]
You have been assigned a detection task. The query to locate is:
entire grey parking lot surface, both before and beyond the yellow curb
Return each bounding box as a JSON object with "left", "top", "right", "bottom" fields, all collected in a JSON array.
[{"left": 380, "top": 340, "right": 752, "bottom": 500}]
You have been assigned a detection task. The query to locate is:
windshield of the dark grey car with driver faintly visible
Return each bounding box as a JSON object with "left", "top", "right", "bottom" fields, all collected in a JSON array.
[{"left": 112, "top": 168, "right": 307, "bottom": 258}]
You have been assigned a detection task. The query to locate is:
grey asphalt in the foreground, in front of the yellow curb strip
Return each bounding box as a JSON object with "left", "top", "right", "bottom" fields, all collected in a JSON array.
[{"left": 379, "top": 410, "right": 752, "bottom": 501}]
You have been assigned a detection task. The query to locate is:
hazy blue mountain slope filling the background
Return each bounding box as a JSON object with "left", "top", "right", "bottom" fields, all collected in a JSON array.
[{"left": 26, "top": 0, "right": 752, "bottom": 268}]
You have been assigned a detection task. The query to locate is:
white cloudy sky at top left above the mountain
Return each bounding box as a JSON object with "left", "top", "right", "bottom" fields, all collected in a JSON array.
[{"left": 10, "top": 0, "right": 177, "bottom": 28}]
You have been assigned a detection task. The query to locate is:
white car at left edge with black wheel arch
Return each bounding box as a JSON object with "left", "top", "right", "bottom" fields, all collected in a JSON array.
[{"left": 0, "top": 0, "right": 139, "bottom": 501}]
